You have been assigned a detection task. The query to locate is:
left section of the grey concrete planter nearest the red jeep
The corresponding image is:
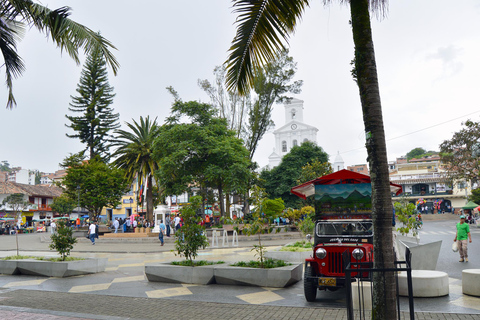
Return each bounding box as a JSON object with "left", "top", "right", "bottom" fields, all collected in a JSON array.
[{"left": 145, "top": 263, "right": 218, "bottom": 284}]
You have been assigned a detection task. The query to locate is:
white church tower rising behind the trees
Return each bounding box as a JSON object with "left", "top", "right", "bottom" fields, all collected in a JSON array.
[{"left": 268, "top": 98, "right": 318, "bottom": 168}]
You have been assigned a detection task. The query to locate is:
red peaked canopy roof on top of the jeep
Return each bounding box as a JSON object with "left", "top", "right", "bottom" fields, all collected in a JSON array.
[{"left": 290, "top": 169, "right": 402, "bottom": 199}]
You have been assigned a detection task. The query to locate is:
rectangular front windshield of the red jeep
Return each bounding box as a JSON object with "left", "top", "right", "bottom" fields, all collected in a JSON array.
[{"left": 316, "top": 221, "right": 373, "bottom": 237}]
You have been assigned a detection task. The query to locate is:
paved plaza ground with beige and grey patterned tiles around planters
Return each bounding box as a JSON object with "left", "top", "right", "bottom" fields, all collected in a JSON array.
[{"left": 0, "top": 221, "right": 480, "bottom": 320}]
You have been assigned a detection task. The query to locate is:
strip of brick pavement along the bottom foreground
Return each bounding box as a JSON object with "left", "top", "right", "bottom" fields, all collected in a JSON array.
[{"left": 0, "top": 289, "right": 480, "bottom": 320}]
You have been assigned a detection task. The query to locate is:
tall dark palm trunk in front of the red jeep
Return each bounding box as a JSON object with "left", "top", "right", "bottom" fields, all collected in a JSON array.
[{"left": 350, "top": 0, "right": 397, "bottom": 319}]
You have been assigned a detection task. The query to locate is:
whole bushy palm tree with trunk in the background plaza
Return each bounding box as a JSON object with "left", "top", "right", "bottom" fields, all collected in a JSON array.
[{"left": 113, "top": 116, "right": 160, "bottom": 221}]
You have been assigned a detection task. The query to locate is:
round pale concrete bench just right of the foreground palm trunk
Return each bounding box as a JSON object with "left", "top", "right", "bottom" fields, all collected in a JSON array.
[{"left": 398, "top": 270, "right": 449, "bottom": 298}]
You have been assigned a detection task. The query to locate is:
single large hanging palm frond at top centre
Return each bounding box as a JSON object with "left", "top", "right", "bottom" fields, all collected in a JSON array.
[{"left": 225, "top": 0, "right": 309, "bottom": 94}]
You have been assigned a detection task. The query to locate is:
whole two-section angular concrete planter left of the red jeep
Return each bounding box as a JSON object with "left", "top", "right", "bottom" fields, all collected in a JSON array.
[{"left": 145, "top": 263, "right": 303, "bottom": 288}]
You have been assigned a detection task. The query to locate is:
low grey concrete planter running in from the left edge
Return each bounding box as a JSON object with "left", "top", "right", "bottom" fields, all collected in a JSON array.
[{"left": 0, "top": 258, "right": 108, "bottom": 278}]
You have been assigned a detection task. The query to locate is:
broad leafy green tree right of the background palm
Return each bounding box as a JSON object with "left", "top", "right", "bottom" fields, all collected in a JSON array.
[{"left": 155, "top": 94, "right": 251, "bottom": 215}]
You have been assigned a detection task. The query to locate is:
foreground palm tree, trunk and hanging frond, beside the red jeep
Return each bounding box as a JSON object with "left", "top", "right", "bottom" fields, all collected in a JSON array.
[{"left": 226, "top": 0, "right": 396, "bottom": 319}]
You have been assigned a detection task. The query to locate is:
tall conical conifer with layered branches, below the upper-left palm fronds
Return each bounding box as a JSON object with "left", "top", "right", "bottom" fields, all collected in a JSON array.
[{"left": 65, "top": 43, "right": 120, "bottom": 160}]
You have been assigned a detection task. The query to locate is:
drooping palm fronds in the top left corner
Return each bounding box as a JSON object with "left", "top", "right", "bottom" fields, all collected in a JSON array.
[{"left": 0, "top": 0, "right": 119, "bottom": 109}]
